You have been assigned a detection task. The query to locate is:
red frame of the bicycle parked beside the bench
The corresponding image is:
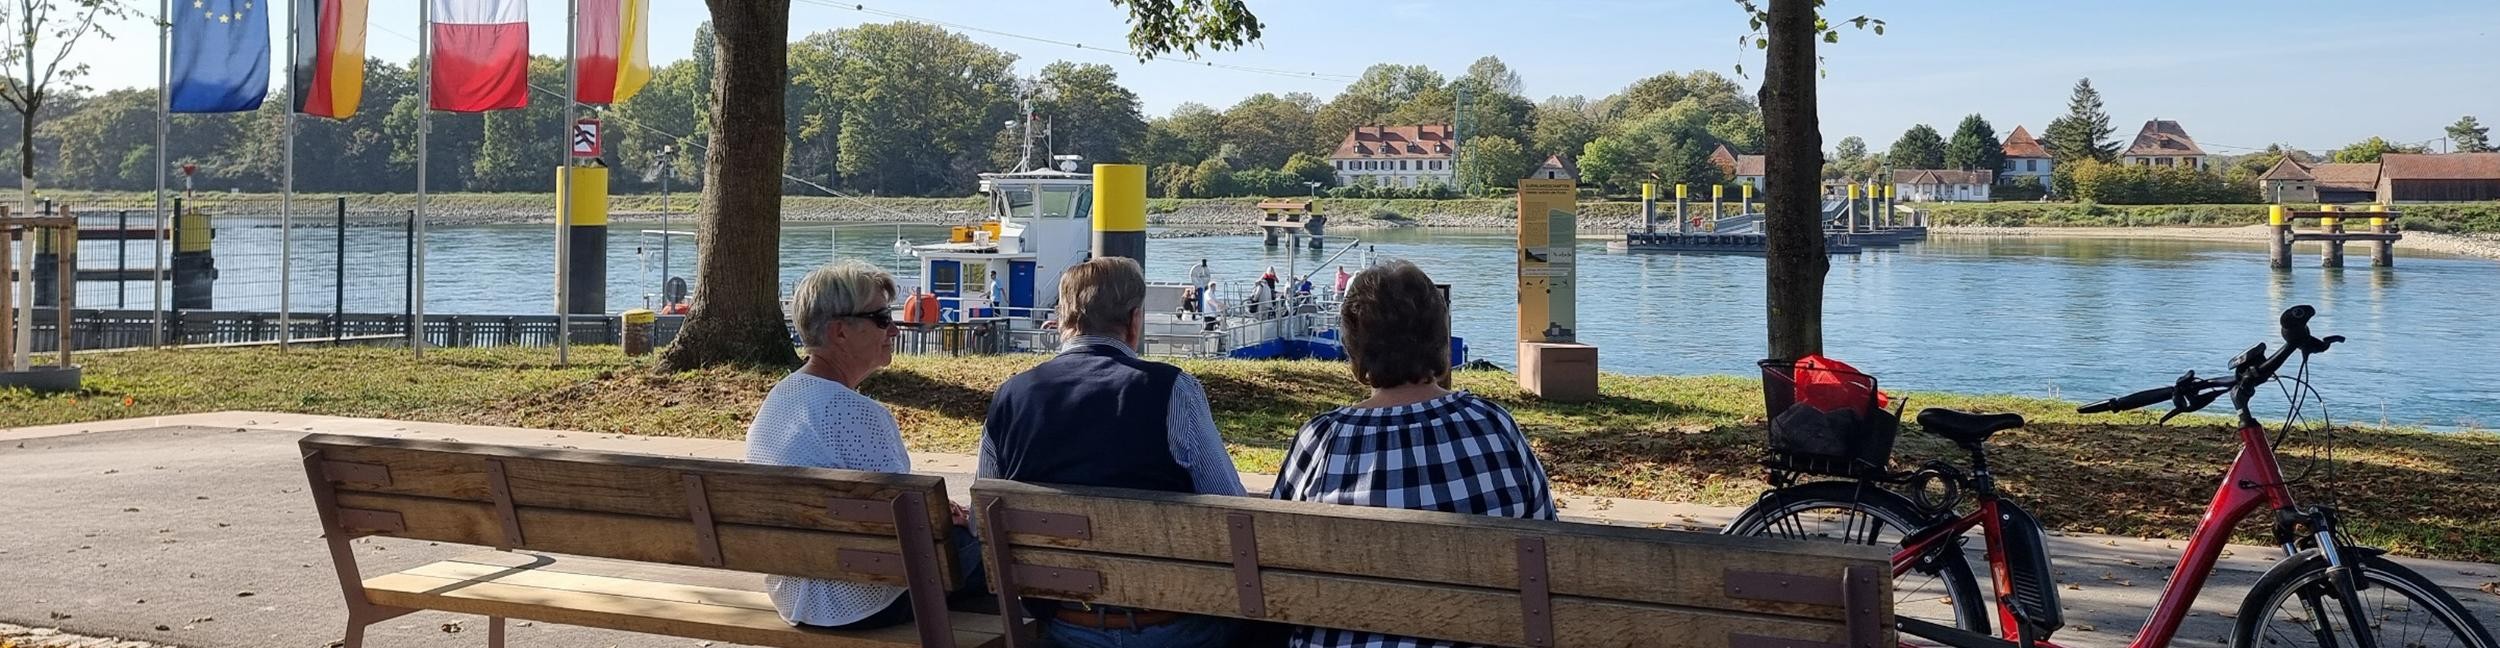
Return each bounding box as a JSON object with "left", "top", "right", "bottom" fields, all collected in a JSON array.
[{"left": 1893, "top": 425, "right": 2300, "bottom": 648}]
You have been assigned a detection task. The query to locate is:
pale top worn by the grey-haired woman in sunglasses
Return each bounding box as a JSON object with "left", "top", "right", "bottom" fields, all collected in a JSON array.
[{"left": 748, "top": 370, "right": 913, "bottom": 625}]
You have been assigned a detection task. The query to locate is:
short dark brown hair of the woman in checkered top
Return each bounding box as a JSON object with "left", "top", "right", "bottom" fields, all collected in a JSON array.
[{"left": 1343, "top": 260, "right": 1450, "bottom": 388}]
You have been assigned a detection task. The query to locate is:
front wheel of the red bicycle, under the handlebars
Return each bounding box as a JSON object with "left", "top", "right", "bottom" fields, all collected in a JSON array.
[{"left": 2230, "top": 550, "right": 2500, "bottom": 648}]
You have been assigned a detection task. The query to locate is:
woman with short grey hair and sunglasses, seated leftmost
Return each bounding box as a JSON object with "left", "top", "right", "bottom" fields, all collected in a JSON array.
[{"left": 748, "top": 260, "right": 995, "bottom": 630}]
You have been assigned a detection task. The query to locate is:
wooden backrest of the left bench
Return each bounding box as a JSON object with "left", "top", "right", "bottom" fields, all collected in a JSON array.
[{"left": 298, "top": 435, "right": 955, "bottom": 590}]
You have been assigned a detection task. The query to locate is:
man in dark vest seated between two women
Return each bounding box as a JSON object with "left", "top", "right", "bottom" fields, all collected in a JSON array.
[{"left": 978, "top": 258, "right": 1243, "bottom": 648}]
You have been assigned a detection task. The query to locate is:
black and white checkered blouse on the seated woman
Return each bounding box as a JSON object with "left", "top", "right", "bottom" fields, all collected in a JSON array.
[{"left": 1273, "top": 390, "right": 1555, "bottom": 648}]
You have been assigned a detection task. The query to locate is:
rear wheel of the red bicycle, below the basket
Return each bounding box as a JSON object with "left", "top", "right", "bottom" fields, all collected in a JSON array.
[{"left": 1720, "top": 480, "right": 1990, "bottom": 635}]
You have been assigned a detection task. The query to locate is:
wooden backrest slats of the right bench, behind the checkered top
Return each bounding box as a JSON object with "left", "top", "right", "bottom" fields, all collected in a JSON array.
[{"left": 973, "top": 480, "right": 1890, "bottom": 620}]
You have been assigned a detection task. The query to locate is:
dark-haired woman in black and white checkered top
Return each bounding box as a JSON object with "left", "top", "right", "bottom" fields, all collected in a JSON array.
[{"left": 1273, "top": 260, "right": 1555, "bottom": 648}]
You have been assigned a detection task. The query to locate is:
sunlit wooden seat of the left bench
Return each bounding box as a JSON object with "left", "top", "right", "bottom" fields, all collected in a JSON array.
[{"left": 365, "top": 560, "right": 1000, "bottom": 648}]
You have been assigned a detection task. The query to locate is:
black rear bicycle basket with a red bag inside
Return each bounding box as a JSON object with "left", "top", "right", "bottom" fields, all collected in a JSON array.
[{"left": 1760, "top": 360, "right": 1900, "bottom": 478}]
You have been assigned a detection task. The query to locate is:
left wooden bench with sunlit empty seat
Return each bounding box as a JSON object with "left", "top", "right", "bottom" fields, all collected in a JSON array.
[{"left": 300, "top": 435, "right": 1003, "bottom": 648}]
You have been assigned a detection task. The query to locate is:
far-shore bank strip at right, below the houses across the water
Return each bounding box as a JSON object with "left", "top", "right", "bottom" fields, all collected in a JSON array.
[{"left": 1918, "top": 203, "right": 2500, "bottom": 233}]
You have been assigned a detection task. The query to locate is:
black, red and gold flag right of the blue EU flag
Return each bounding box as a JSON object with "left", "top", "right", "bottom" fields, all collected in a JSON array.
[{"left": 288, "top": 0, "right": 368, "bottom": 120}]
